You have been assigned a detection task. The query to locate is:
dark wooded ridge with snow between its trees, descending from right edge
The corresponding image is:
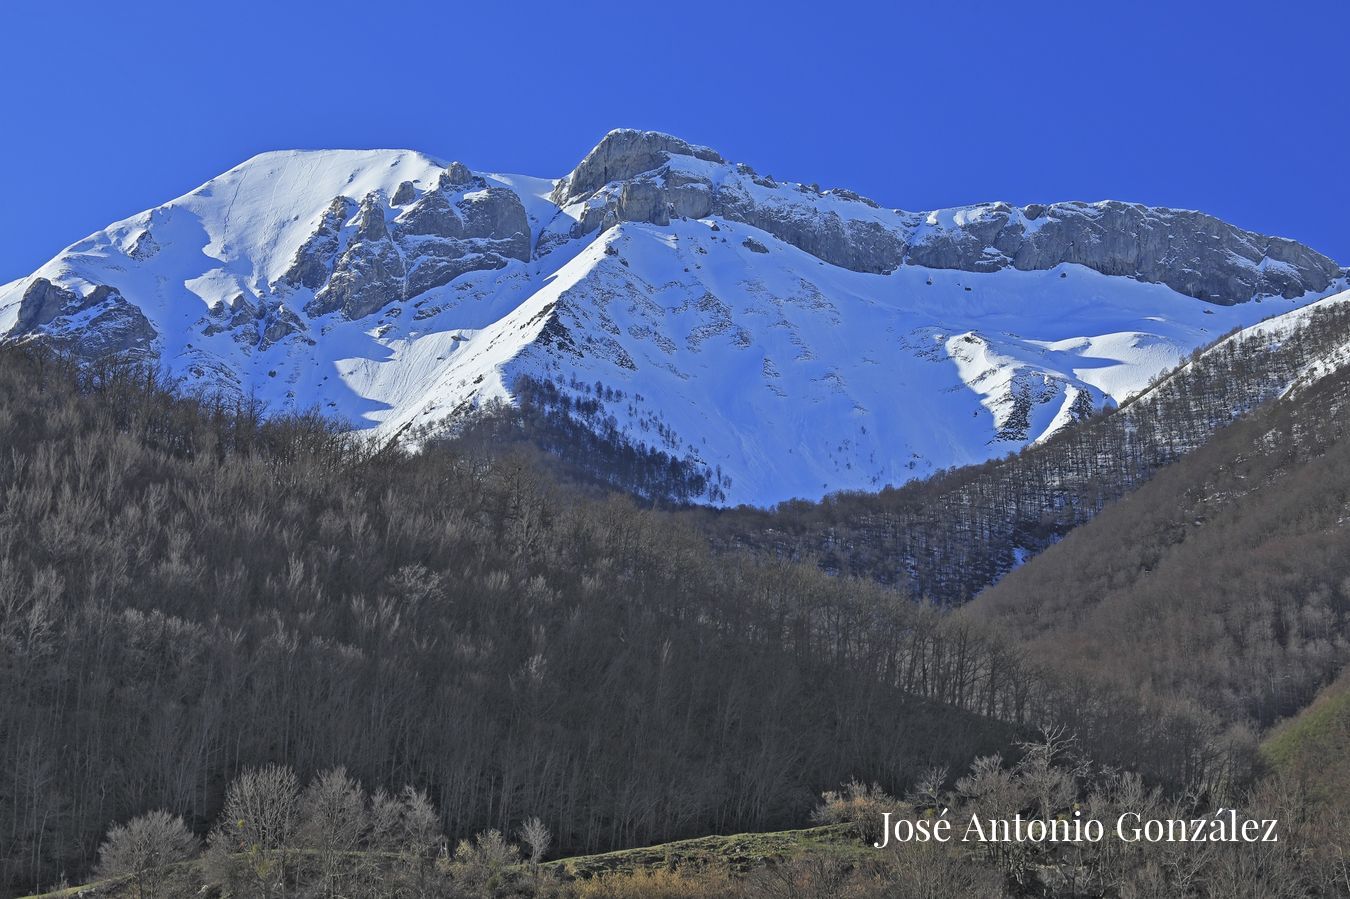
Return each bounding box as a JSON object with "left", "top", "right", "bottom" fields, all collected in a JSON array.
[{"left": 697, "top": 296, "right": 1350, "bottom": 605}]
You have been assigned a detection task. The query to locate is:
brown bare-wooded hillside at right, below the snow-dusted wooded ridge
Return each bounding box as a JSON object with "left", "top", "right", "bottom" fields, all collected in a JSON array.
[{"left": 967, "top": 345, "right": 1350, "bottom": 772}]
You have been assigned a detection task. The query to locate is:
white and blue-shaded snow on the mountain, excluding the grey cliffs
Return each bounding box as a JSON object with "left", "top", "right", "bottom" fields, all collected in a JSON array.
[{"left": 0, "top": 150, "right": 1330, "bottom": 505}]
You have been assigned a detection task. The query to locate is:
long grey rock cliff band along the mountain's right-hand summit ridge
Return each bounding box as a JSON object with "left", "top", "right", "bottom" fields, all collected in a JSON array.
[{"left": 554, "top": 131, "right": 1342, "bottom": 305}]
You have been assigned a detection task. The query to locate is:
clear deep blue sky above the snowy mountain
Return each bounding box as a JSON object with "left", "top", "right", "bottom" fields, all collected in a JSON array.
[{"left": 0, "top": 0, "right": 1350, "bottom": 281}]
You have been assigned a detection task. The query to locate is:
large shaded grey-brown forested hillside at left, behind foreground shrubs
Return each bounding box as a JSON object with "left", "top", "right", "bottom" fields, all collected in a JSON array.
[{"left": 0, "top": 348, "right": 1037, "bottom": 890}]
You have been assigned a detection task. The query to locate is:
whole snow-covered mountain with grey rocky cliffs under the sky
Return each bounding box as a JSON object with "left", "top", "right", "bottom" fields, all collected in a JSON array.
[{"left": 0, "top": 131, "right": 1346, "bottom": 503}]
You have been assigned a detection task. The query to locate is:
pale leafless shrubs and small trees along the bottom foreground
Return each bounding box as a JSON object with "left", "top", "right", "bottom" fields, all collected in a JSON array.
[{"left": 99, "top": 728, "right": 1350, "bottom": 899}]
